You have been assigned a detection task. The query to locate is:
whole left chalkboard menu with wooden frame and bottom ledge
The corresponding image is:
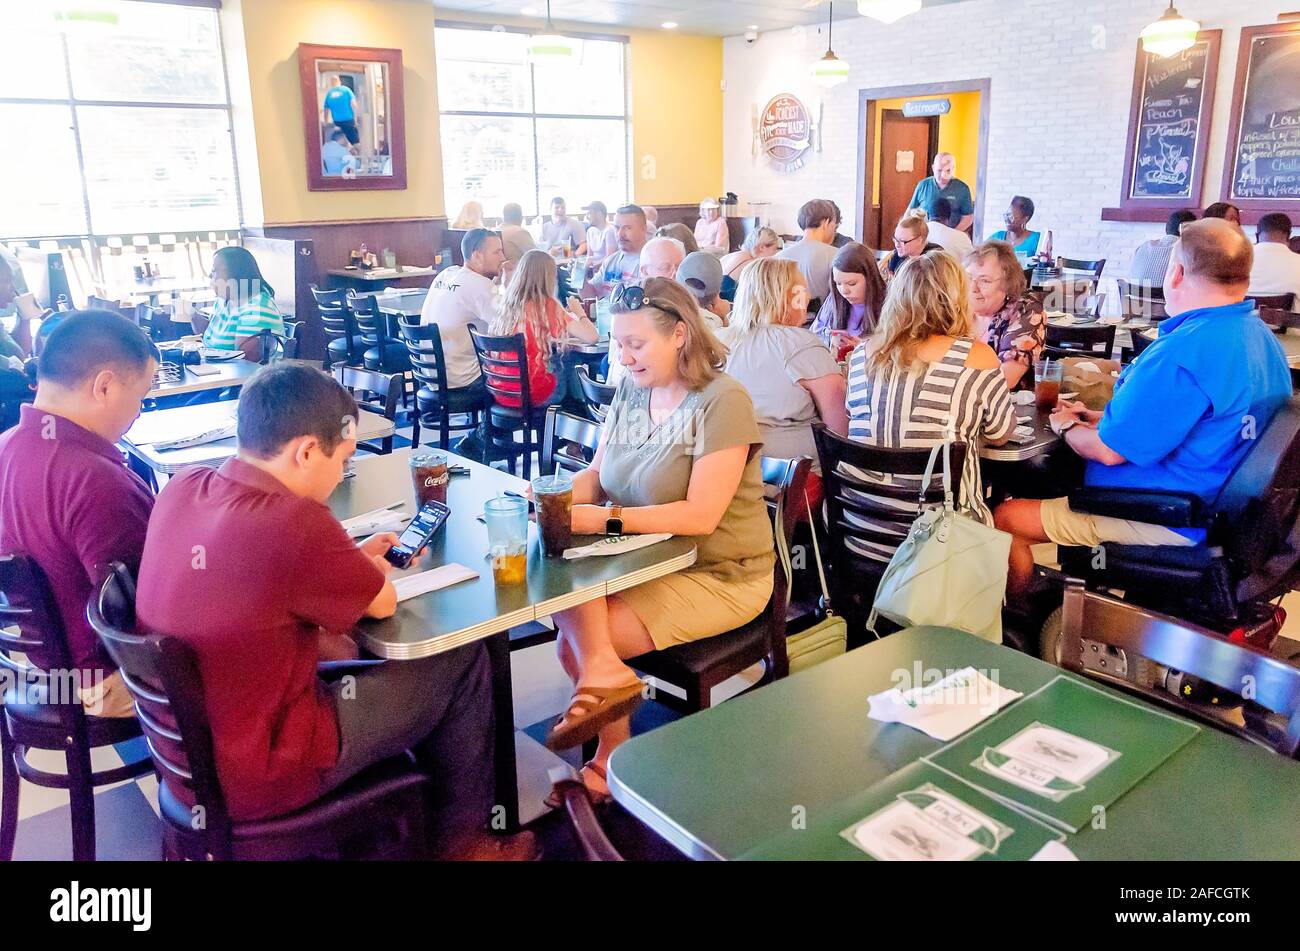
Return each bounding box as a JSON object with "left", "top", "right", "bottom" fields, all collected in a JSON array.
[{"left": 1102, "top": 30, "right": 1222, "bottom": 221}]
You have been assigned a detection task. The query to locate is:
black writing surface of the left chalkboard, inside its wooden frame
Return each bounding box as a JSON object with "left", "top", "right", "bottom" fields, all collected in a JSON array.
[{"left": 1127, "top": 39, "right": 1216, "bottom": 204}]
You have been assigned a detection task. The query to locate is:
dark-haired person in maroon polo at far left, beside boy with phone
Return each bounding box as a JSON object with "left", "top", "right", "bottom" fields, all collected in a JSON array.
[{"left": 0, "top": 311, "right": 159, "bottom": 716}]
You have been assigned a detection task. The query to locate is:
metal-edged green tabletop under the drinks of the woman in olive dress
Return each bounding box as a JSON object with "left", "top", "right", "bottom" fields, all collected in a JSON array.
[{"left": 329, "top": 450, "right": 696, "bottom": 660}]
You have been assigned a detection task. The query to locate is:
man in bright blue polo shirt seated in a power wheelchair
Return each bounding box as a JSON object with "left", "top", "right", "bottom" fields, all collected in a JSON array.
[{"left": 996, "top": 218, "right": 1291, "bottom": 595}]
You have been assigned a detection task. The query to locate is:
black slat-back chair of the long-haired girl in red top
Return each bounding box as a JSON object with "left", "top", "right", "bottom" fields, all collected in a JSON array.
[{"left": 469, "top": 327, "right": 547, "bottom": 479}]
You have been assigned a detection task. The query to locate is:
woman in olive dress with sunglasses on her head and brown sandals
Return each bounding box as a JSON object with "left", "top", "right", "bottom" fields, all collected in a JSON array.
[{"left": 547, "top": 278, "right": 775, "bottom": 798}]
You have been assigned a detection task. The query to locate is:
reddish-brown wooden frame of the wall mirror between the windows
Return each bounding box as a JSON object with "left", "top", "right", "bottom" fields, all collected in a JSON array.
[{"left": 298, "top": 43, "right": 407, "bottom": 191}]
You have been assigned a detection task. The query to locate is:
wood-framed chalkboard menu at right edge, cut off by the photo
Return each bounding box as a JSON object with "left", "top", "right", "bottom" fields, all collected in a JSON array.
[{"left": 1223, "top": 23, "right": 1300, "bottom": 209}]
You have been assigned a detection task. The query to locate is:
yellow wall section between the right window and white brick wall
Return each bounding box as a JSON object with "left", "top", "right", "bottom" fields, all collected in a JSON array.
[{"left": 628, "top": 31, "right": 723, "bottom": 205}]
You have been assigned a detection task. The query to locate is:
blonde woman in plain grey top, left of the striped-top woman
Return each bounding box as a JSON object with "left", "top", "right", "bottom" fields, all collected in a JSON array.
[{"left": 727, "top": 252, "right": 849, "bottom": 505}]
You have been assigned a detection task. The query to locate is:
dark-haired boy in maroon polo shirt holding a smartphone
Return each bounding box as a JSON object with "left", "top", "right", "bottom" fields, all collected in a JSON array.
[{"left": 135, "top": 364, "right": 533, "bottom": 859}]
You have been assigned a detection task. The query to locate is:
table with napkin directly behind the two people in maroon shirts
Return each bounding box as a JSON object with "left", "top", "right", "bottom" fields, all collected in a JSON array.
[{"left": 121, "top": 399, "right": 397, "bottom": 488}]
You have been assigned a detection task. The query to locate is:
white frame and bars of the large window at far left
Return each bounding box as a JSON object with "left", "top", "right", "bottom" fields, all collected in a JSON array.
[{"left": 0, "top": 0, "right": 243, "bottom": 242}]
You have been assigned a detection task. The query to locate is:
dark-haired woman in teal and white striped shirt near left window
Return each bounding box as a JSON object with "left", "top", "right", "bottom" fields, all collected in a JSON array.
[{"left": 191, "top": 247, "right": 285, "bottom": 360}]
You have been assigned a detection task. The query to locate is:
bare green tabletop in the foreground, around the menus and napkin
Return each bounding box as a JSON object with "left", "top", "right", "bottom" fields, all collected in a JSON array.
[{"left": 610, "top": 628, "right": 1300, "bottom": 860}]
